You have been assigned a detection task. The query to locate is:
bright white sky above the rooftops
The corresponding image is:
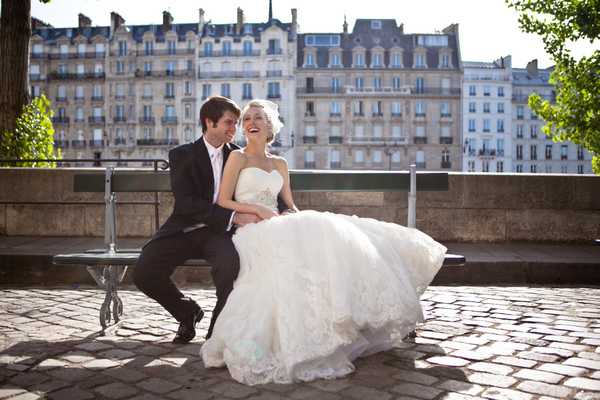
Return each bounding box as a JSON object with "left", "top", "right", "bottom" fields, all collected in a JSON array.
[{"left": 31, "top": 0, "right": 598, "bottom": 68}]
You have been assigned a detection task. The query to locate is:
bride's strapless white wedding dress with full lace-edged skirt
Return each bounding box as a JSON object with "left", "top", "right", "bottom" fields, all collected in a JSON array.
[{"left": 201, "top": 167, "right": 446, "bottom": 385}]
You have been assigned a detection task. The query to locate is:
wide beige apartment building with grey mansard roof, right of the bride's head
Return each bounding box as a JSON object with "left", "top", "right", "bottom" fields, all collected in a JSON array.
[{"left": 295, "top": 19, "right": 462, "bottom": 170}]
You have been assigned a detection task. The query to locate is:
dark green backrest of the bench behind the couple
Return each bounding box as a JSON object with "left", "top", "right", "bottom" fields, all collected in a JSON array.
[{"left": 73, "top": 169, "right": 448, "bottom": 192}]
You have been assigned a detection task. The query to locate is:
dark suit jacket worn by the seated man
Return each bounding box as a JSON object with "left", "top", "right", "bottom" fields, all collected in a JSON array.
[{"left": 152, "top": 138, "right": 238, "bottom": 240}]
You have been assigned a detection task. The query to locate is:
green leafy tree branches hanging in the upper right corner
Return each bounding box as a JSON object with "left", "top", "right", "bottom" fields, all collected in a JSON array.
[{"left": 506, "top": 0, "right": 600, "bottom": 175}]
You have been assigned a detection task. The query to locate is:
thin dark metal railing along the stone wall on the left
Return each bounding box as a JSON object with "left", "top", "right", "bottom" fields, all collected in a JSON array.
[{"left": 0, "top": 158, "right": 169, "bottom": 231}]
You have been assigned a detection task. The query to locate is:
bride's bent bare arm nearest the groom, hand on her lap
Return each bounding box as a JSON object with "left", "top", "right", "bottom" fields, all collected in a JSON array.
[{"left": 217, "top": 151, "right": 273, "bottom": 219}]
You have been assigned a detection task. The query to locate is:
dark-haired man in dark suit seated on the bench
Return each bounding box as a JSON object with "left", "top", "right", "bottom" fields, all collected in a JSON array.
[{"left": 133, "top": 96, "right": 258, "bottom": 343}]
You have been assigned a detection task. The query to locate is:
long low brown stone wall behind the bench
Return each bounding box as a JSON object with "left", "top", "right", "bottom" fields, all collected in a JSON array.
[{"left": 0, "top": 168, "right": 600, "bottom": 242}]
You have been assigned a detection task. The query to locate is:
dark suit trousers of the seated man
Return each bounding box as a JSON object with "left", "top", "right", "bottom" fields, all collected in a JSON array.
[{"left": 133, "top": 228, "right": 240, "bottom": 337}]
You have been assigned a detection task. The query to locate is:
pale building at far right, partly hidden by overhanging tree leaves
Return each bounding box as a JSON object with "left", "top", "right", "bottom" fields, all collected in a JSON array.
[{"left": 512, "top": 60, "right": 592, "bottom": 174}]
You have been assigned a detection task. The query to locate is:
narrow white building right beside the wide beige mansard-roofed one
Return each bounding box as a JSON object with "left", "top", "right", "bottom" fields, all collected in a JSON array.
[{"left": 462, "top": 56, "right": 512, "bottom": 172}]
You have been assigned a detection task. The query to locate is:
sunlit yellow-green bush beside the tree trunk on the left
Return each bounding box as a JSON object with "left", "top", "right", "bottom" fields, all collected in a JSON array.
[{"left": 0, "top": 95, "right": 61, "bottom": 167}]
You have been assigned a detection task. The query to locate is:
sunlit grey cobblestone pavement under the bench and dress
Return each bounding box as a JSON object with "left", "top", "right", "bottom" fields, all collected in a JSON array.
[{"left": 0, "top": 286, "right": 600, "bottom": 400}]
